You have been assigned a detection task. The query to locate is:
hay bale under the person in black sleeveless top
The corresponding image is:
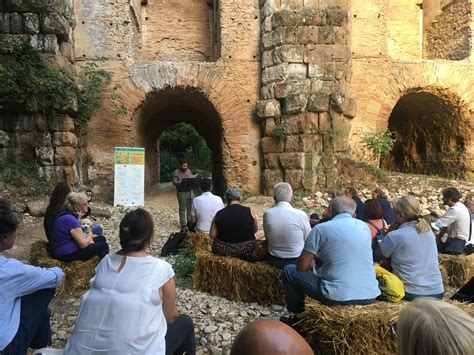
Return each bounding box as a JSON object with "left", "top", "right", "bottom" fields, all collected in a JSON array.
[{"left": 194, "top": 250, "right": 284, "bottom": 304}]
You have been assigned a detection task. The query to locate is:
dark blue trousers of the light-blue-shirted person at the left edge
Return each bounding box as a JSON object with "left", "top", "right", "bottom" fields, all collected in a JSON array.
[{"left": 1, "top": 288, "right": 56, "bottom": 355}]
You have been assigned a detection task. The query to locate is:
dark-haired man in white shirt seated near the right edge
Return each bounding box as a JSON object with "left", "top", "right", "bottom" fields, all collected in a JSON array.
[{"left": 432, "top": 187, "right": 471, "bottom": 255}]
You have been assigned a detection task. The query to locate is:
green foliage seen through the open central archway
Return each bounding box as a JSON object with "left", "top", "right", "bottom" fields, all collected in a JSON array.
[{"left": 160, "top": 122, "right": 212, "bottom": 182}]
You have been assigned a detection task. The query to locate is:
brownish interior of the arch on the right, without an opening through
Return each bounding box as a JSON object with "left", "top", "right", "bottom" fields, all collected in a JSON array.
[{"left": 382, "top": 90, "right": 470, "bottom": 177}]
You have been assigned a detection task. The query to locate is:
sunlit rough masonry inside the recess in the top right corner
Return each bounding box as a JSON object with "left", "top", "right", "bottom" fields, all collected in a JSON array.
[{"left": 424, "top": 0, "right": 472, "bottom": 60}]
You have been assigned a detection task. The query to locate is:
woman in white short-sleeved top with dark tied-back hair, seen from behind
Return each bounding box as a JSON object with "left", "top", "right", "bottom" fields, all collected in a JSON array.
[{"left": 65, "top": 209, "right": 196, "bottom": 355}]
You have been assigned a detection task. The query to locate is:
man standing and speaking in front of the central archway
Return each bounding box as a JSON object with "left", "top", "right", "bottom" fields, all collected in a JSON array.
[{"left": 171, "top": 158, "right": 195, "bottom": 229}]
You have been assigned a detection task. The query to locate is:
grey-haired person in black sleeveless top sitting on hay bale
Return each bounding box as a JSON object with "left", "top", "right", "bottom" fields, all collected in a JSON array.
[{"left": 209, "top": 187, "right": 258, "bottom": 258}]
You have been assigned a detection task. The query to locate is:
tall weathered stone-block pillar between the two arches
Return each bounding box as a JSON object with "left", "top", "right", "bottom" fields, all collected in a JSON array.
[{"left": 257, "top": 1, "right": 356, "bottom": 192}]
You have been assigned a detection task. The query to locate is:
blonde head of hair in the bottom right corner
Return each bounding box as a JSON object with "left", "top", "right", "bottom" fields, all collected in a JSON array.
[{"left": 397, "top": 298, "right": 474, "bottom": 355}]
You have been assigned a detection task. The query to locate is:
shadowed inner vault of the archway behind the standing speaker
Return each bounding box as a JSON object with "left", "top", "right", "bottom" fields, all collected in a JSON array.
[{"left": 135, "top": 89, "right": 225, "bottom": 194}]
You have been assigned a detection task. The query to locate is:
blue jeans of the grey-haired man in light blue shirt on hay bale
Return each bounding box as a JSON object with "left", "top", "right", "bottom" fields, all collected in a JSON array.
[{"left": 283, "top": 265, "right": 375, "bottom": 313}]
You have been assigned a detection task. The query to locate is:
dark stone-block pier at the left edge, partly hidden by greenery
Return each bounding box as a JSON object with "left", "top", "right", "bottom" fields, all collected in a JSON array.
[{"left": 0, "top": 0, "right": 78, "bottom": 183}]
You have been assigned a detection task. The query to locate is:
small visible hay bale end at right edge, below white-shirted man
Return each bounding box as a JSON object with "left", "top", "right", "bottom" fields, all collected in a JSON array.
[{"left": 439, "top": 254, "right": 474, "bottom": 288}]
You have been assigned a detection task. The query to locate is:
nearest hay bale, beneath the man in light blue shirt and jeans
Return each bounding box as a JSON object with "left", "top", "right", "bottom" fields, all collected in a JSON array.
[{"left": 300, "top": 298, "right": 474, "bottom": 354}]
